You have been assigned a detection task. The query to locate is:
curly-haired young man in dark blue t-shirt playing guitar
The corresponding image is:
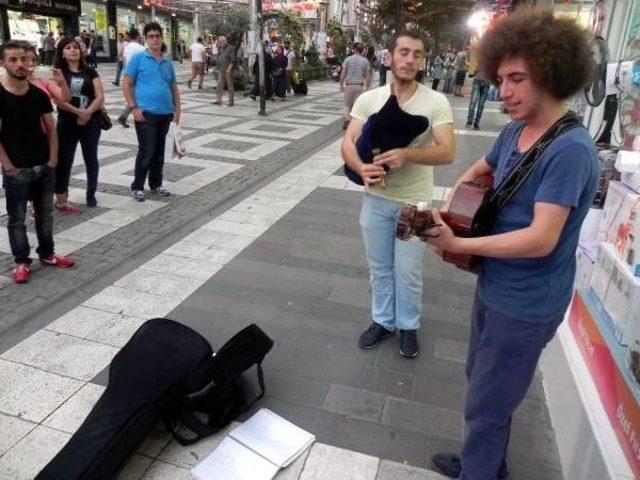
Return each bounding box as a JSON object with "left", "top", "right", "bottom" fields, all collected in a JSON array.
[{"left": 428, "top": 8, "right": 598, "bottom": 480}]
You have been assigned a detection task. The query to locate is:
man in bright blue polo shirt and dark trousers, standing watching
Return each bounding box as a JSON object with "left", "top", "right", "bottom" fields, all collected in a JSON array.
[{"left": 123, "top": 22, "right": 180, "bottom": 202}]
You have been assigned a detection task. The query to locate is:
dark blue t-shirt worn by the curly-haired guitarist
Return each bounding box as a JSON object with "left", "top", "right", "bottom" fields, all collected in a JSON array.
[{"left": 478, "top": 122, "right": 599, "bottom": 323}]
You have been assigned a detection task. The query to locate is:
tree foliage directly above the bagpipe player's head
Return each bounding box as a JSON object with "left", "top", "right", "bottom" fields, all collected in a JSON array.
[{"left": 366, "top": 0, "right": 475, "bottom": 47}]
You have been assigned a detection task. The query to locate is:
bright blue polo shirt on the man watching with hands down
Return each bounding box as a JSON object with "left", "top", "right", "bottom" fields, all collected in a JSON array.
[{"left": 124, "top": 50, "right": 176, "bottom": 115}]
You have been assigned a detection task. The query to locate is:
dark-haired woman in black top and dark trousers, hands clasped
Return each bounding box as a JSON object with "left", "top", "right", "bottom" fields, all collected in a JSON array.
[{"left": 54, "top": 38, "right": 104, "bottom": 210}]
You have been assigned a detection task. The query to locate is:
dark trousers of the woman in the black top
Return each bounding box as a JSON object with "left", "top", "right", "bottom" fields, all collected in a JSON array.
[{"left": 55, "top": 115, "right": 102, "bottom": 197}]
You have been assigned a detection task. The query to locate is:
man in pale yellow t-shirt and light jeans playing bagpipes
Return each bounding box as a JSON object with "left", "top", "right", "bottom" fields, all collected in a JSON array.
[{"left": 342, "top": 32, "right": 455, "bottom": 358}]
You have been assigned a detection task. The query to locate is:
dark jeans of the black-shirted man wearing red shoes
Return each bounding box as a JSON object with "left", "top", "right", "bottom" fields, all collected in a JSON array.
[{"left": 2, "top": 165, "right": 55, "bottom": 264}]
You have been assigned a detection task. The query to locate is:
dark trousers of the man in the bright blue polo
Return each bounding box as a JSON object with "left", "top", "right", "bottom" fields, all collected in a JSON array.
[{"left": 131, "top": 112, "right": 173, "bottom": 190}]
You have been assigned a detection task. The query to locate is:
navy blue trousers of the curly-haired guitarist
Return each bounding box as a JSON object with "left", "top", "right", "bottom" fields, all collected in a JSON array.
[{"left": 460, "top": 292, "right": 564, "bottom": 480}]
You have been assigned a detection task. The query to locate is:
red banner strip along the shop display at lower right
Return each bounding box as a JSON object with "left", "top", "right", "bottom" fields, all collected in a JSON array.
[{"left": 569, "top": 291, "right": 640, "bottom": 478}]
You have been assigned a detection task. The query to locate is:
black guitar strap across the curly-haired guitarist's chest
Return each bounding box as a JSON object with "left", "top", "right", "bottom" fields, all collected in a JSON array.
[{"left": 471, "top": 111, "right": 582, "bottom": 236}]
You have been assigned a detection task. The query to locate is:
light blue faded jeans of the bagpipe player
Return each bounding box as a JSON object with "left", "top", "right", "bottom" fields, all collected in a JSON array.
[{"left": 360, "top": 193, "right": 425, "bottom": 331}]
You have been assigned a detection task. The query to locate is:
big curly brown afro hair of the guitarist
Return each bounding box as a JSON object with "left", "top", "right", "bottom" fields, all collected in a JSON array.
[{"left": 478, "top": 7, "right": 593, "bottom": 100}]
